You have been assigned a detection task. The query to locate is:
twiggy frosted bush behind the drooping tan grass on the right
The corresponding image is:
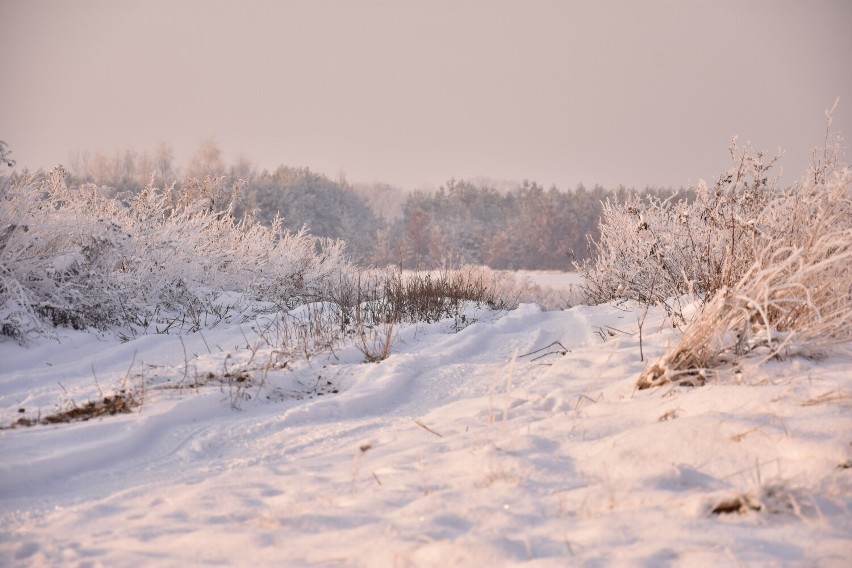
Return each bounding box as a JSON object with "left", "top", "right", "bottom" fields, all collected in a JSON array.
[{"left": 577, "top": 139, "right": 779, "bottom": 303}]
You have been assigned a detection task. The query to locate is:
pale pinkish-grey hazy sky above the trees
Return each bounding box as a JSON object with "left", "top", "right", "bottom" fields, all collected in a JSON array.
[{"left": 0, "top": 0, "right": 852, "bottom": 188}]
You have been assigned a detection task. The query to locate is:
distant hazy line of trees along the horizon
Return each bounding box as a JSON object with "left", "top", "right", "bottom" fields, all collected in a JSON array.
[{"left": 63, "top": 140, "right": 674, "bottom": 270}]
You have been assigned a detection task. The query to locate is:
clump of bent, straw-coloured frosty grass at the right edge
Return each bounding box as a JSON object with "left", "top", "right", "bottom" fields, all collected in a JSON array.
[{"left": 638, "top": 230, "right": 852, "bottom": 388}]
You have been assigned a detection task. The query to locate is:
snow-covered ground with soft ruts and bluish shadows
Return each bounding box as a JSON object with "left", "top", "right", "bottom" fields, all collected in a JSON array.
[{"left": 0, "top": 305, "right": 852, "bottom": 566}]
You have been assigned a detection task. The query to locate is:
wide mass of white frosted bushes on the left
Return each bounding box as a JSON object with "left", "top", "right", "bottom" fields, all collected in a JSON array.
[{"left": 0, "top": 169, "right": 348, "bottom": 340}]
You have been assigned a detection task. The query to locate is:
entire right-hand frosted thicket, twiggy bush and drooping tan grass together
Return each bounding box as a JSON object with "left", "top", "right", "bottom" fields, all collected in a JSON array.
[{"left": 578, "top": 112, "right": 852, "bottom": 388}]
